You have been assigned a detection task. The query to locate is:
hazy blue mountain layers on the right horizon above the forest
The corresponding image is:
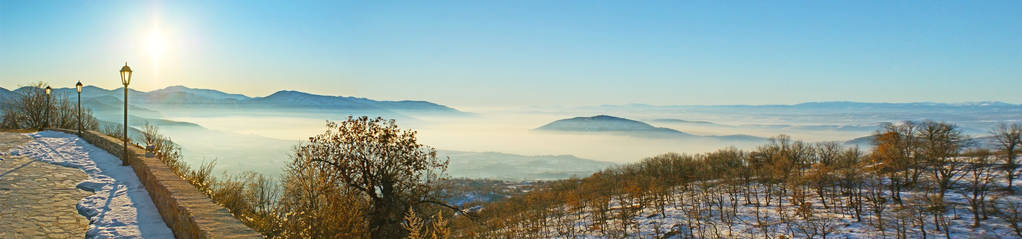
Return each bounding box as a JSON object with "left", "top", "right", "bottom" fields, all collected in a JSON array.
[{"left": 592, "top": 101, "right": 1022, "bottom": 135}]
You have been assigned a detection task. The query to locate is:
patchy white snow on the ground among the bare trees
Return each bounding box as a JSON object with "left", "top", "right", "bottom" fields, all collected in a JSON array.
[{"left": 519, "top": 173, "right": 1022, "bottom": 238}]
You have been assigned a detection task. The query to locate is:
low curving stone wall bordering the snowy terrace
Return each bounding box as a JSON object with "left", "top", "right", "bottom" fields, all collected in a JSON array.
[{"left": 50, "top": 129, "right": 262, "bottom": 238}]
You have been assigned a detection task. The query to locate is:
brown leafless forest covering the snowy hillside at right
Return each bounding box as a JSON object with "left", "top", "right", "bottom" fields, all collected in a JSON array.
[{"left": 453, "top": 122, "right": 1022, "bottom": 238}]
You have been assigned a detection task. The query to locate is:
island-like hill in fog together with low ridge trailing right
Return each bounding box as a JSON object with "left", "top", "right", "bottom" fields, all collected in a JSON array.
[{"left": 536, "top": 115, "right": 765, "bottom": 141}]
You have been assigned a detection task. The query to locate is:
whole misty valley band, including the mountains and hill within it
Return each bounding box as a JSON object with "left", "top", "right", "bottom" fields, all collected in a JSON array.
[{"left": 6, "top": 86, "right": 1022, "bottom": 180}]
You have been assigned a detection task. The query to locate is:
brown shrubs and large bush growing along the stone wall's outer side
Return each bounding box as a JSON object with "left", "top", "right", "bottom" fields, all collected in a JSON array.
[{"left": 136, "top": 117, "right": 454, "bottom": 238}]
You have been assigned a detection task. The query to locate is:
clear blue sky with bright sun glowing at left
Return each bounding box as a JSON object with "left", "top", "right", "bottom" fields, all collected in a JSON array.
[{"left": 0, "top": 0, "right": 1022, "bottom": 107}]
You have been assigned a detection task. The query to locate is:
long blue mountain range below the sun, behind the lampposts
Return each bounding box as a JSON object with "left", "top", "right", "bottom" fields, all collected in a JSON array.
[{"left": 6, "top": 86, "right": 463, "bottom": 113}]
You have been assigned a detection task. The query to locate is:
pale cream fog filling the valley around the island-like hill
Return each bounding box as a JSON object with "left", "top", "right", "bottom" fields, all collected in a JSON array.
[{"left": 137, "top": 107, "right": 887, "bottom": 176}]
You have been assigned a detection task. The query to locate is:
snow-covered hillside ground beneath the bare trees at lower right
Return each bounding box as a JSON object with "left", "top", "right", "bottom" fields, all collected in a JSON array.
[{"left": 510, "top": 174, "right": 1022, "bottom": 238}]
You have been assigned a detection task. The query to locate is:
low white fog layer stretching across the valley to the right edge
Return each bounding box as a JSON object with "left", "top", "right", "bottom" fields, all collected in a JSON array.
[{"left": 123, "top": 102, "right": 1020, "bottom": 177}]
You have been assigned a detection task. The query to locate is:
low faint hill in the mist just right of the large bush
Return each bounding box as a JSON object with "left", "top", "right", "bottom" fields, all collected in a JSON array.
[{"left": 438, "top": 151, "right": 614, "bottom": 180}]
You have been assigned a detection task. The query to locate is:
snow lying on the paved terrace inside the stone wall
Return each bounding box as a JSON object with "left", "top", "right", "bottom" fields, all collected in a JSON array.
[{"left": 10, "top": 131, "right": 174, "bottom": 238}]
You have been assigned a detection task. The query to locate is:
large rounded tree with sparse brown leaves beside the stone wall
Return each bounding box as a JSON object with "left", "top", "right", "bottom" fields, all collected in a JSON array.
[{"left": 294, "top": 116, "right": 453, "bottom": 238}]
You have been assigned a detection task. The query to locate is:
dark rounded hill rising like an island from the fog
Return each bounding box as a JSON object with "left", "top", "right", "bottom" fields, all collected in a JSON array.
[{"left": 536, "top": 115, "right": 692, "bottom": 136}]
